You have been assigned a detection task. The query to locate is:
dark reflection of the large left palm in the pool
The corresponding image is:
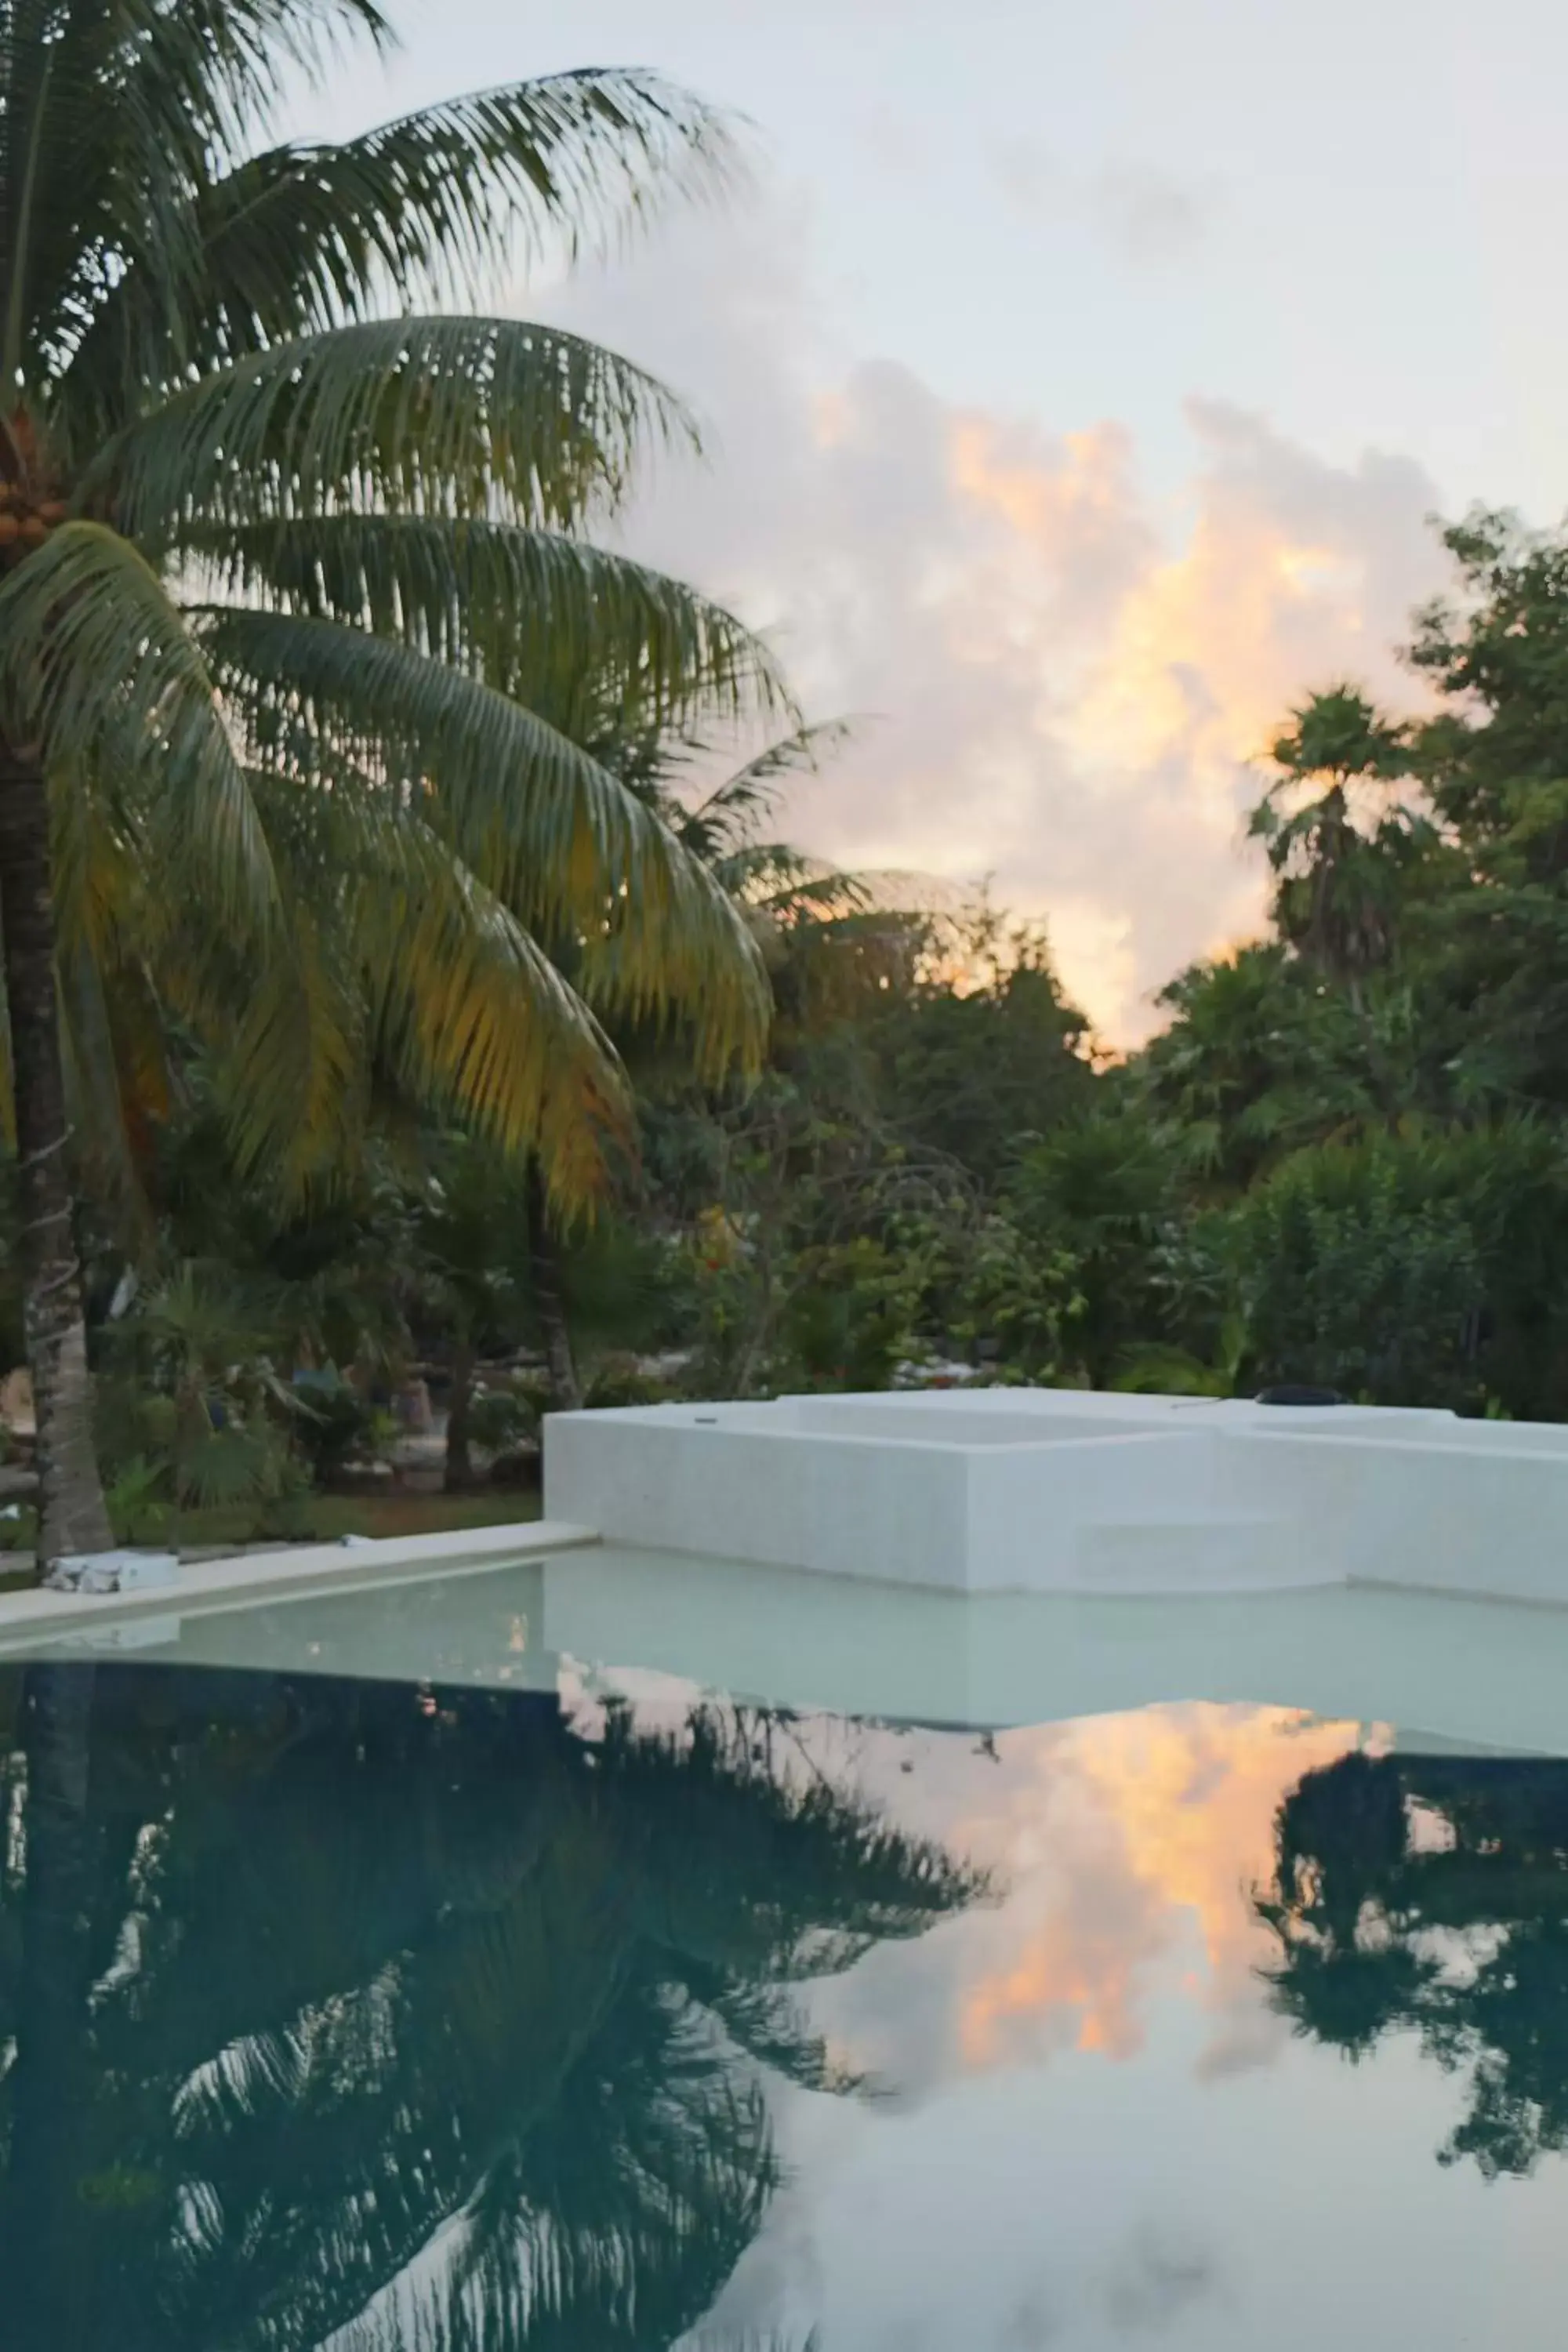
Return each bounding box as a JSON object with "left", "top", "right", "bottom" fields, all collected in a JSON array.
[{"left": 0, "top": 1668, "right": 978, "bottom": 2352}]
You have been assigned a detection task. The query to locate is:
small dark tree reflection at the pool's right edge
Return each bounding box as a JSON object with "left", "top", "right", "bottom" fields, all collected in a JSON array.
[{"left": 1258, "top": 1755, "right": 1568, "bottom": 2178}]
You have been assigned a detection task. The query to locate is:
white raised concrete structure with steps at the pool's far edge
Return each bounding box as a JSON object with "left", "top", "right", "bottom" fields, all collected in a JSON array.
[{"left": 546, "top": 1388, "right": 1568, "bottom": 1602}]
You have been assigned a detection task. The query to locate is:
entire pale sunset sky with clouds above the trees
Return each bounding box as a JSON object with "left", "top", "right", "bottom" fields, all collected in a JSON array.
[{"left": 296, "top": 0, "right": 1568, "bottom": 1044}]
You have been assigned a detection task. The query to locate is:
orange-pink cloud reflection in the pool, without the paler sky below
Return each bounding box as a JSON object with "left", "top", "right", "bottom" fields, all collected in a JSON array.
[{"left": 820, "top": 1705, "right": 1361, "bottom": 2100}]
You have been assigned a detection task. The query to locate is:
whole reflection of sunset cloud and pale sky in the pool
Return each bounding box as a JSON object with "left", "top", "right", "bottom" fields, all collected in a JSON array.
[{"left": 691, "top": 1705, "right": 1568, "bottom": 2352}]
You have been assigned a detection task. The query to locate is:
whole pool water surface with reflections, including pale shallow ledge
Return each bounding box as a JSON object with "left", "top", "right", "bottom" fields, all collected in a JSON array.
[{"left": 0, "top": 1555, "right": 1568, "bottom": 2352}]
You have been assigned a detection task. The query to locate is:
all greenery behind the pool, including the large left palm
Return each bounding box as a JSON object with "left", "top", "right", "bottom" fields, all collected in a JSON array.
[{"left": 15, "top": 18, "right": 1568, "bottom": 1576}]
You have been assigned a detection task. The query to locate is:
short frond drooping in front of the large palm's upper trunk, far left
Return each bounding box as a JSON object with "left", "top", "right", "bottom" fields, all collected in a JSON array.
[{"left": 0, "top": 522, "right": 275, "bottom": 931}]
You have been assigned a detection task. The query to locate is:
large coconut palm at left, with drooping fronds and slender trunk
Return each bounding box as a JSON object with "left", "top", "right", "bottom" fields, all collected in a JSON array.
[{"left": 0, "top": 0, "right": 776, "bottom": 1581}]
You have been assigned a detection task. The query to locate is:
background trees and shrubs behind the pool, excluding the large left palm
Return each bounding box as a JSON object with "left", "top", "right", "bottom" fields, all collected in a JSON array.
[{"left": 21, "top": 503, "right": 1568, "bottom": 1526}]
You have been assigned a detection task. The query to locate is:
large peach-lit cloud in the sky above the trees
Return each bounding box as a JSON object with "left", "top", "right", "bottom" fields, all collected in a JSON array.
[{"left": 533, "top": 202, "right": 1441, "bottom": 1042}]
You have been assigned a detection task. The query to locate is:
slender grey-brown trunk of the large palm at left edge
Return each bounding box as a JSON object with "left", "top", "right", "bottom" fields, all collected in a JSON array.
[{"left": 0, "top": 743, "right": 113, "bottom": 1583}]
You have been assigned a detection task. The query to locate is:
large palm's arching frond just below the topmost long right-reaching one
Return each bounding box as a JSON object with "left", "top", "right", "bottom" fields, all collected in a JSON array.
[{"left": 80, "top": 318, "right": 696, "bottom": 548}]
